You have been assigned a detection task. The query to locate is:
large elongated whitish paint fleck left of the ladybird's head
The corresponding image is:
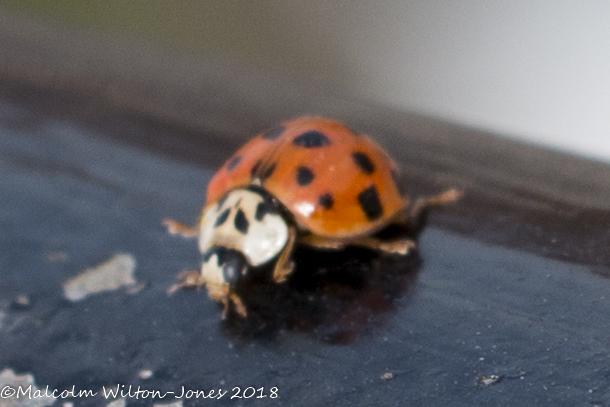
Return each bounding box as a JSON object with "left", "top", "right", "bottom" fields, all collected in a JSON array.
[{"left": 64, "top": 253, "right": 136, "bottom": 301}]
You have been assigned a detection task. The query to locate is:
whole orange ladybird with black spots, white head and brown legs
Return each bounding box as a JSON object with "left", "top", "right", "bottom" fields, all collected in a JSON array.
[{"left": 164, "top": 117, "right": 460, "bottom": 317}]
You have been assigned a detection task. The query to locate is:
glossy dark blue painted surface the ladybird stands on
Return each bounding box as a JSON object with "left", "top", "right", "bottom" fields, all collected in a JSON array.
[{"left": 0, "top": 81, "right": 610, "bottom": 406}]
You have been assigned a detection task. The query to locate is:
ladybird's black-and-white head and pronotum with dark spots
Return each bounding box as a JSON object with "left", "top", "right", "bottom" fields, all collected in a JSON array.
[{"left": 199, "top": 189, "right": 289, "bottom": 298}]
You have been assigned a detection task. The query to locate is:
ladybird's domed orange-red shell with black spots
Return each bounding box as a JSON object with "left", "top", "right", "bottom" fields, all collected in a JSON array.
[{"left": 206, "top": 117, "right": 407, "bottom": 239}]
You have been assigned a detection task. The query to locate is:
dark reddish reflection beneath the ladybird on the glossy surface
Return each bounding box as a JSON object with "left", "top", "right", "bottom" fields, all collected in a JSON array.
[{"left": 223, "top": 248, "right": 421, "bottom": 344}]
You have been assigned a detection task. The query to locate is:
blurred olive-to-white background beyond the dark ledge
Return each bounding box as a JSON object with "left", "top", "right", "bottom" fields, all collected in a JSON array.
[{"left": 0, "top": 0, "right": 610, "bottom": 161}]
